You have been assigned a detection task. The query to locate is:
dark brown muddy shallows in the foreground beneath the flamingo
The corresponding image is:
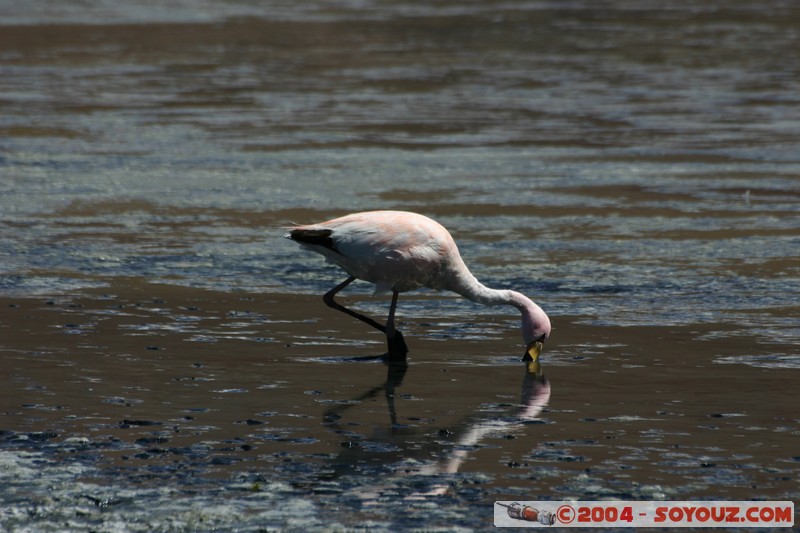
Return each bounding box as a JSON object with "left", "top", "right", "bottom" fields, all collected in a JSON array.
[{"left": 0, "top": 279, "right": 800, "bottom": 531}]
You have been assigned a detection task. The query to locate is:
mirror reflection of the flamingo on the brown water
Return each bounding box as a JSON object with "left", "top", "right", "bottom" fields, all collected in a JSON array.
[{"left": 323, "top": 362, "right": 551, "bottom": 502}]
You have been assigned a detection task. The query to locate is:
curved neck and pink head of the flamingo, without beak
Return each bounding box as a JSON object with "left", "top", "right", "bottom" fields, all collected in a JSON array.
[{"left": 450, "top": 273, "right": 550, "bottom": 344}]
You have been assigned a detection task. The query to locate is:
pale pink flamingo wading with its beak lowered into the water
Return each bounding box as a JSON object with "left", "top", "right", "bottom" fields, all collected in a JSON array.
[{"left": 286, "top": 211, "right": 550, "bottom": 362}]
